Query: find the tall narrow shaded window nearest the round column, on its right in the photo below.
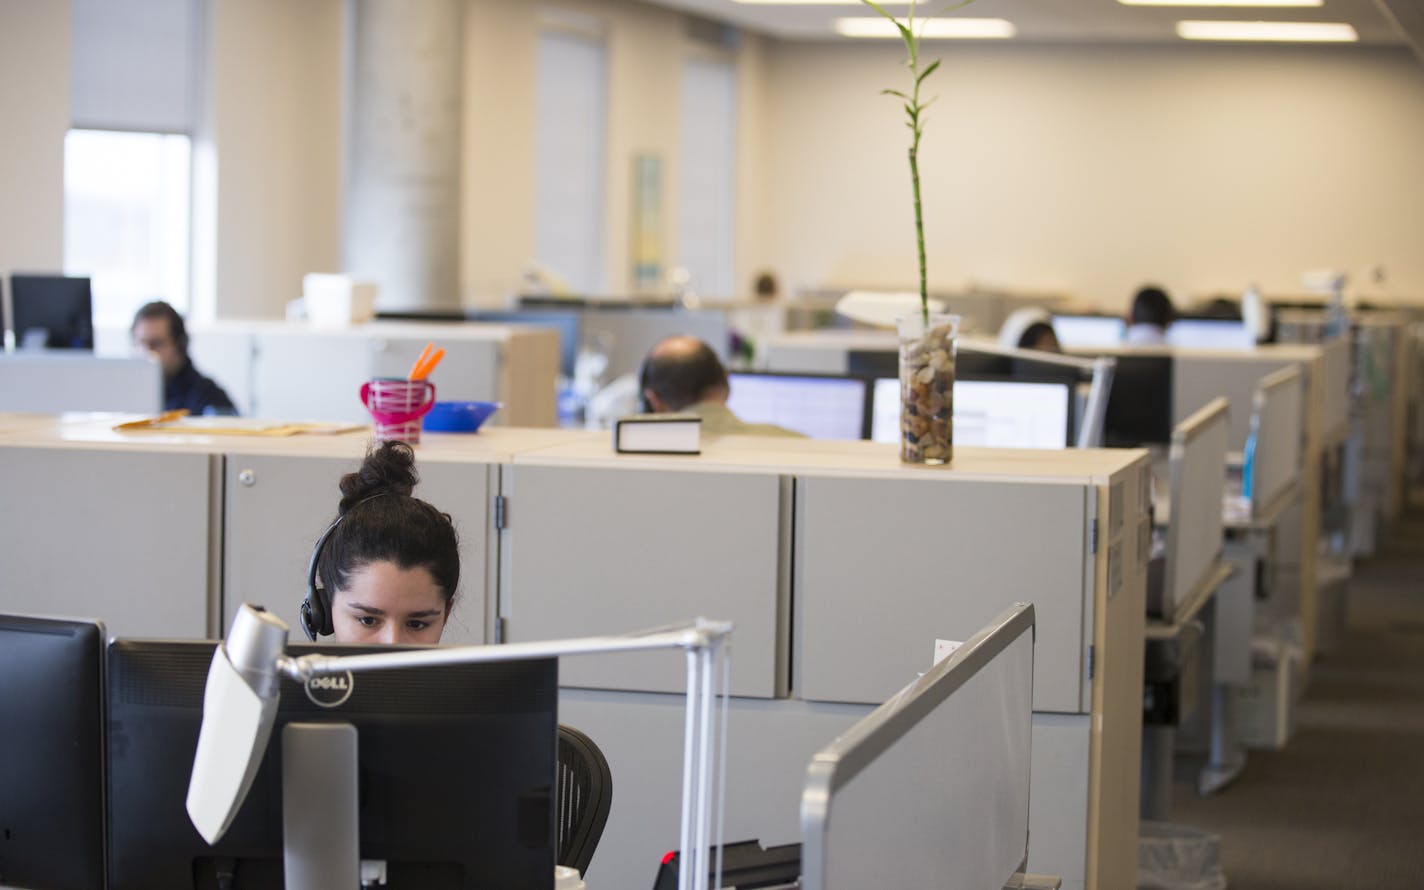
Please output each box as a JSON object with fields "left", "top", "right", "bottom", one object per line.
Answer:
{"left": 534, "top": 28, "right": 607, "bottom": 293}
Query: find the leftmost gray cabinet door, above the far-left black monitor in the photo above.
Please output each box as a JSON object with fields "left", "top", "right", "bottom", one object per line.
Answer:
{"left": 0, "top": 447, "right": 222, "bottom": 639}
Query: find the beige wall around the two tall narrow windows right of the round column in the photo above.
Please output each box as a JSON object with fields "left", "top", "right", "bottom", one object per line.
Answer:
{"left": 460, "top": 0, "right": 762, "bottom": 305}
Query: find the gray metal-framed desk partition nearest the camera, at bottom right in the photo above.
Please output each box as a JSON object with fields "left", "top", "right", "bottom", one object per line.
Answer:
{"left": 802, "top": 604, "right": 1034, "bottom": 890}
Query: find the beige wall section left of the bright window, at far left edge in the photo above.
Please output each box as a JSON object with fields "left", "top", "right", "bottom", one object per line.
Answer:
{"left": 0, "top": 0, "right": 70, "bottom": 280}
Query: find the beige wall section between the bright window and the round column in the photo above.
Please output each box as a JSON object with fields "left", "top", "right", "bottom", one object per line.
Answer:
{"left": 211, "top": 0, "right": 343, "bottom": 318}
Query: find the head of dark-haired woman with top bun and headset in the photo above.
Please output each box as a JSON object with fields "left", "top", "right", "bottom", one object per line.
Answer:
{"left": 300, "top": 441, "right": 460, "bottom": 645}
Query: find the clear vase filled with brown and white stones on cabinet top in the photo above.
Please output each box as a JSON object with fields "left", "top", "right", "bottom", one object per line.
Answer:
{"left": 896, "top": 312, "right": 960, "bottom": 464}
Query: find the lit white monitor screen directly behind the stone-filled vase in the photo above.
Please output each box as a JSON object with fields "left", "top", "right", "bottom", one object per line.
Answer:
{"left": 870, "top": 377, "right": 1074, "bottom": 449}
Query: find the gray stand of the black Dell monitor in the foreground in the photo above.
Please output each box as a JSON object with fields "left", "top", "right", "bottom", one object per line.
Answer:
{"left": 282, "top": 723, "right": 362, "bottom": 890}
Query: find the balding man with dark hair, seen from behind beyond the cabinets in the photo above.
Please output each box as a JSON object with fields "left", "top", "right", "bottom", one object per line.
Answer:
{"left": 638, "top": 335, "right": 802, "bottom": 437}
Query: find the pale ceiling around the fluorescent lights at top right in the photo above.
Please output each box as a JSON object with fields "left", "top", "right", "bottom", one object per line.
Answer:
{"left": 652, "top": 0, "right": 1407, "bottom": 46}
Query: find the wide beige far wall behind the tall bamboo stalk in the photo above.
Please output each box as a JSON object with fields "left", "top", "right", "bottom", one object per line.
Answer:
{"left": 763, "top": 44, "right": 1424, "bottom": 306}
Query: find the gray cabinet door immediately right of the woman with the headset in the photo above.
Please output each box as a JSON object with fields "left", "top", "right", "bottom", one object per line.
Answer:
{"left": 500, "top": 463, "right": 790, "bottom": 698}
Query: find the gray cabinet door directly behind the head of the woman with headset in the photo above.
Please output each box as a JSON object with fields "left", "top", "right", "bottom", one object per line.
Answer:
{"left": 221, "top": 453, "right": 494, "bottom": 645}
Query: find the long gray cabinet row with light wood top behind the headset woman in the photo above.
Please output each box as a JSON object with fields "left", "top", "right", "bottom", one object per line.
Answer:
{"left": 0, "top": 417, "right": 1151, "bottom": 890}
